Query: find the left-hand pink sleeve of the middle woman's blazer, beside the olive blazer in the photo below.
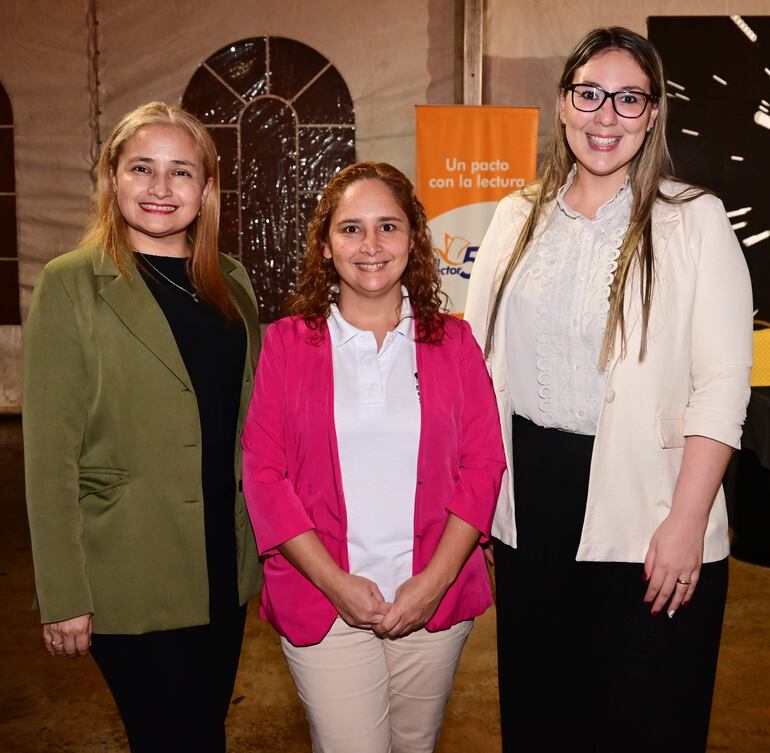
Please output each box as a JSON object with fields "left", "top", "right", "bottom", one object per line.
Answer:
{"left": 242, "top": 325, "right": 314, "bottom": 555}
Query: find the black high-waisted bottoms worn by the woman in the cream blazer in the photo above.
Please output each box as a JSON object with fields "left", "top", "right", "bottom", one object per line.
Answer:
{"left": 494, "top": 416, "right": 727, "bottom": 753}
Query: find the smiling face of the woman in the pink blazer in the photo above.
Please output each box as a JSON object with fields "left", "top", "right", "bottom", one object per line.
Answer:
{"left": 323, "top": 179, "right": 411, "bottom": 310}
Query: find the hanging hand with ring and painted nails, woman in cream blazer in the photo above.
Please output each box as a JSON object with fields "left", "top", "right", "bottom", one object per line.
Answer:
{"left": 644, "top": 510, "right": 706, "bottom": 617}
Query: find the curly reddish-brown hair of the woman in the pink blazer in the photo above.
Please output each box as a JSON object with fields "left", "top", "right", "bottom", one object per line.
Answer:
{"left": 286, "top": 162, "right": 446, "bottom": 344}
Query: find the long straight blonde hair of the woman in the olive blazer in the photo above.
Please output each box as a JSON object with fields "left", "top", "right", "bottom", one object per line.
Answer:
{"left": 81, "top": 102, "right": 237, "bottom": 319}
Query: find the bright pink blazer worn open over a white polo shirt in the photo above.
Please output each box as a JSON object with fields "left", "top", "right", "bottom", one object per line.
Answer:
{"left": 243, "top": 317, "right": 505, "bottom": 646}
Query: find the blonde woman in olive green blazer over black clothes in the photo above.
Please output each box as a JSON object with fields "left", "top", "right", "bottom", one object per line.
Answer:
{"left": 23, "top": 103, "right": 260, "bottom": 753}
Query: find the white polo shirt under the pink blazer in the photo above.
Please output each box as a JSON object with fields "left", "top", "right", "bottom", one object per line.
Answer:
{"left": 327, "top": 288, "right": 420, "bottom": 601}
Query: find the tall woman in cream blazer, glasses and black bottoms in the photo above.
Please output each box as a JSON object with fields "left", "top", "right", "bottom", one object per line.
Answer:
{"left": 465, "top": 28, "right": 752, "bottom": 753}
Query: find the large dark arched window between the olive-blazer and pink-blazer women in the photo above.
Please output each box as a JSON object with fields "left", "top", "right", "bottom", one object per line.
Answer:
{"left": 182, "top": 37, "right": 355, "bottom": 322}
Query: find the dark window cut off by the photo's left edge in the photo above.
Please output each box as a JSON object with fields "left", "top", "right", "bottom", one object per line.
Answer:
{"left": 0, "top": 84, "right": 21, "bottom": 324}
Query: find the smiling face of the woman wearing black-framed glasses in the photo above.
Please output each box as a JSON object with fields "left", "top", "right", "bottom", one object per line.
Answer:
{"left": 559, "top": 49, "right": 657, "bottom": 189}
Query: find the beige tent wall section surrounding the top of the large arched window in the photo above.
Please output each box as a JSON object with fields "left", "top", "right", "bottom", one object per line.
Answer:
{"left": 99, "top": 0, "right": 438, "bottom": 188}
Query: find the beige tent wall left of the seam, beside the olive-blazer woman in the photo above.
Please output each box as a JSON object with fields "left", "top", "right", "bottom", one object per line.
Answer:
{"left": 0, "top": 0, "right": 91, "bottom": 411}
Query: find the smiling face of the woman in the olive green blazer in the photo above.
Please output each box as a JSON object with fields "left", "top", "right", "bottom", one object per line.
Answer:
{"left": 113, "top": 124, "right": 212, "bottom": 256}
